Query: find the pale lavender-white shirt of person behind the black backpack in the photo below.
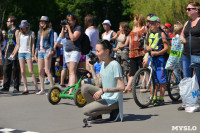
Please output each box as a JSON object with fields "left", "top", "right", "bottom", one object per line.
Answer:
{"left": 85, "top": 29, "right": 99, "bottom": 51}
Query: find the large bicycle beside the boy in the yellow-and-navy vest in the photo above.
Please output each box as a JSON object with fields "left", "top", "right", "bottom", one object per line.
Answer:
{"left": 132, "top": 37, "right": 183, "bottom": 108}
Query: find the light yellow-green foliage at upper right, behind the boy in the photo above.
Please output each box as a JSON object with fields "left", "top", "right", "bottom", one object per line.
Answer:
{"left": 128, "top": 0, "right": 200, "bottom": 24}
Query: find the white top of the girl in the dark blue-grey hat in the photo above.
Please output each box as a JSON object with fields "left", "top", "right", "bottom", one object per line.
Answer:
{"left": 19, "top": 34, "right": 31, "bottom": 53}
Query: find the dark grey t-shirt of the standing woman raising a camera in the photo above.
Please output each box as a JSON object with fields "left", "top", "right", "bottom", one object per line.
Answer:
{"left": 65, "top": 25, "right": 83, "bottom": 52}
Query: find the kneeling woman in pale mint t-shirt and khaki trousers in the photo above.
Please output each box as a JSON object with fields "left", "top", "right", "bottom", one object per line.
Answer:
{"left": 81, "top": 40, "right": 124, "bottom": 121}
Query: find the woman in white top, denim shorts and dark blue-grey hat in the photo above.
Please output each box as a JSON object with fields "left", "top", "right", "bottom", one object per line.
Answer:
{"left": 10, "top": 20, "right": 38, "bottom": 94}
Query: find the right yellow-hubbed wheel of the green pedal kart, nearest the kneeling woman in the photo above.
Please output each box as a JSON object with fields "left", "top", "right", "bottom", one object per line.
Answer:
{"left": 74, "top": 88, "right": 87, "bottom": 107}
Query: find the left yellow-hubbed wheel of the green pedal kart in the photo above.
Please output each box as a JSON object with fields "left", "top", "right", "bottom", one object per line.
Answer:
{"left": 47, "top": 86, "right": 61, "bottom": 105}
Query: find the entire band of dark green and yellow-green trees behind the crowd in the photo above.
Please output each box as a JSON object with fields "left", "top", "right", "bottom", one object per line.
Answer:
{"left": 0, "top": 0, "right": 200, "bottom": 32}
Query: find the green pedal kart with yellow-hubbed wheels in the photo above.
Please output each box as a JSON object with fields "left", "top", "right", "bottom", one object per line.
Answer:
{"left": 47, "top": 68, "right": 91, "bottom": 107}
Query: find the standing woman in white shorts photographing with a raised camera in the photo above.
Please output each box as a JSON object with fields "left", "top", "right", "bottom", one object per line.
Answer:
{"left": 61, "top": 14, "right": 83, "bottom": 94}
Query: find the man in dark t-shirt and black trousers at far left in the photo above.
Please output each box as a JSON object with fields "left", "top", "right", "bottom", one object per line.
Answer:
{"left": 0, "top": 16, "right": 20, "bottom": 93}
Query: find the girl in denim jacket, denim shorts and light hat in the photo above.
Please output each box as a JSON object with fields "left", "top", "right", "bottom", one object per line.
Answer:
{"left": 35, "top": 16, "right": 54, "bottom": 95}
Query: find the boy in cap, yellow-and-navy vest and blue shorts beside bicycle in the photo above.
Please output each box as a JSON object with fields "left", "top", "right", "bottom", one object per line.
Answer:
{"left": 146, "top": 16, "right": 168, "bottom": 106}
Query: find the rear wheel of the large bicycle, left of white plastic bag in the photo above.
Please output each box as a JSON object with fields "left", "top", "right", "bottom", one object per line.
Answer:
{"left": 167, "top": 70, "right": 183, "bottom": 101}
